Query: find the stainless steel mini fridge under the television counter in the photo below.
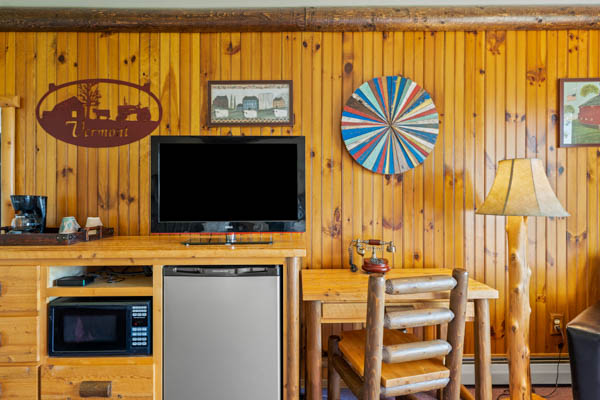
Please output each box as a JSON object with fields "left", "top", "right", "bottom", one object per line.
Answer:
{"left": 163, "top": 266, "right": 282, "bottom": 400}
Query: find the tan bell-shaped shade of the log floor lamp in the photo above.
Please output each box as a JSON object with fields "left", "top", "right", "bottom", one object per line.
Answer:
{"left": 476, "top": 158, "right": 569, "bottom": 217}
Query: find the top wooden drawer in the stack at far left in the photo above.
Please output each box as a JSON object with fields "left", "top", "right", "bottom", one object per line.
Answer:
{"left": 0, "top": 267, "right": 40, "bottom": 316}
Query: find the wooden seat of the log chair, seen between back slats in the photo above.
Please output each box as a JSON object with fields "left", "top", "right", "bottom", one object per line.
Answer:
{"left": 339, "top": 329, "right": 450, "bottom": 388}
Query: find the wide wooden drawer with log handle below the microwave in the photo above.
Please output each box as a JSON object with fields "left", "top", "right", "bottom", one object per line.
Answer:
{"left": 41, "top": 365, "right": 153, "bottom": 400}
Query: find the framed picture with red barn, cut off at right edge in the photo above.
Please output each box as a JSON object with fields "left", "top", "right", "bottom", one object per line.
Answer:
{"left": 559, "top": 78, "right": 600, "bottom": 147}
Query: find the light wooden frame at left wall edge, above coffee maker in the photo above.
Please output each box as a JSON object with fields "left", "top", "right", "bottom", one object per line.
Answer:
{"left": 0, "top": 96, "right": 20, "bottom": 226}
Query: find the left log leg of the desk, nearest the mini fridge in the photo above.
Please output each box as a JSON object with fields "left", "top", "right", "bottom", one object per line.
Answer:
{"left": 306, "top": 301, "right": 323, "bottom": 400}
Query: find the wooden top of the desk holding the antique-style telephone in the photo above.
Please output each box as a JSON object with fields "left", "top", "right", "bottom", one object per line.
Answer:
{"left": 301, "top": 268, "right": 498, "bottom": 303}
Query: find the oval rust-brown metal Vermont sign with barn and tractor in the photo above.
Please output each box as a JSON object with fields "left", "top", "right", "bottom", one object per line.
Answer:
{"left": 35, "top": 79, "right": 162, "bottom": 147}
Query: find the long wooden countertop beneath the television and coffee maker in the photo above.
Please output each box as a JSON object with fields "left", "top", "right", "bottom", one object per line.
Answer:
{"left": 0, "top": 235, "right": 306, "bottom": 265}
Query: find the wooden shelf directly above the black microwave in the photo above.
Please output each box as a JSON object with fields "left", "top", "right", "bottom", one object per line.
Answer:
{"left": 46, "top": 276, "right": 152, "bottom": 297}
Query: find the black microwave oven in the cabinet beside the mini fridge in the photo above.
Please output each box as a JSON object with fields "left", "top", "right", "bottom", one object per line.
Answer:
{"left": 48, "top": 297, "right": 152, "bottom": 357}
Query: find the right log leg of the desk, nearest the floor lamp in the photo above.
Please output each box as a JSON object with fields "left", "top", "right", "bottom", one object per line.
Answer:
{"left": 475, "top": 299, "right": 492, "bottom": 400}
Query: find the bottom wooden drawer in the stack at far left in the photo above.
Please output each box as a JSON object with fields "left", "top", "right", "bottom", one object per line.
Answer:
{"left": 0, "top": 367, "right": 37, "bottom": 400}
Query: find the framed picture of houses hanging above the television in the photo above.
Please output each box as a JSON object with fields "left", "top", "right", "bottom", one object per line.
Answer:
{"left": 207, "top": 81, "right": 294, "bottom": 126}
